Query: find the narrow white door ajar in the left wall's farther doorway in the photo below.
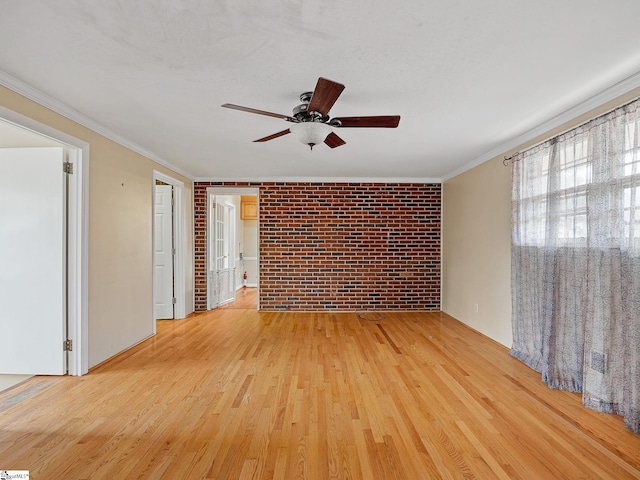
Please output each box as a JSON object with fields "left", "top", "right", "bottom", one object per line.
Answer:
{"left": 153, "top": 185, "right": 174, "bottom": 319}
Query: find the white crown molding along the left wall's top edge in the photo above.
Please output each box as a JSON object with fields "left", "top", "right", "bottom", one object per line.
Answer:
{"left": 0, "top": 70, "right": 193, "bottom": 180}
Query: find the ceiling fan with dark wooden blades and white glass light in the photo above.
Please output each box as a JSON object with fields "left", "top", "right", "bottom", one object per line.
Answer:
{"left": 222, "top": 77, "right": 400, "bottom": 150}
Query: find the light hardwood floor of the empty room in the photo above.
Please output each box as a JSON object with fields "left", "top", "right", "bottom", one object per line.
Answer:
{"left": 0, "top": 309, "right": 640, "bottom": 480}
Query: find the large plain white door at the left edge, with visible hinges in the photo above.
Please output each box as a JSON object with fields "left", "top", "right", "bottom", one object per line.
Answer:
{"left": 0, "top": 148, "right": 67, "bottom": 375}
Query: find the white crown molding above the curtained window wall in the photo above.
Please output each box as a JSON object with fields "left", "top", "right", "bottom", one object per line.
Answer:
{"left": 442, "top": 72, "right": 640, "bottom": 182}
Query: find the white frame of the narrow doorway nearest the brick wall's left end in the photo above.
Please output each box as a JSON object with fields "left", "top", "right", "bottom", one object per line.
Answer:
{"left": 151, "top": 170, "right": 186, "bottom": 335}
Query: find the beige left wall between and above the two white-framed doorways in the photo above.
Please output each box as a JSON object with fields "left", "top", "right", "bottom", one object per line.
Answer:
{"left": 0, "top": 87, "right": 193, "bottom": 367}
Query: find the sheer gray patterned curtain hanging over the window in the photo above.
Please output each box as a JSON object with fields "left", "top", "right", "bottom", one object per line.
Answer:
{"left": 511, "top": 101, "right": 640, "bottom": 433}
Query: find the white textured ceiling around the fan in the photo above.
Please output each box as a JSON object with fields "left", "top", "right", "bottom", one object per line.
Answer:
{"left": 0, "top": 0, "right": 640, "bottom": 181}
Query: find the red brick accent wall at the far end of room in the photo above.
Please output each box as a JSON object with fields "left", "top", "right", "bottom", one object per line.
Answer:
{"left": 194, "top": 182, "right": 441, "bottom": 310}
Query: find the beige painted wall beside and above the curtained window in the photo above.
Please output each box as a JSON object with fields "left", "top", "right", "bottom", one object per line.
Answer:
{"left": 442, "top": 89, "right": 640, "bottom": 347}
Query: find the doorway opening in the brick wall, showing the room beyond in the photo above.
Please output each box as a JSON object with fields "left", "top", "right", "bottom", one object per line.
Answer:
{"left": 207, "top": 187, "right": 259, "bottom": 310}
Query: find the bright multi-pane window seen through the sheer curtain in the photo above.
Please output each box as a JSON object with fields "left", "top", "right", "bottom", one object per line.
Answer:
{"left": 513, "top": 116, "right": 640, "bottom": 250}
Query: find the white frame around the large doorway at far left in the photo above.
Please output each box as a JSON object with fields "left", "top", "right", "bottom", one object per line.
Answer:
{"left": 0, "top": 106, "right": 89, "bottom": 376}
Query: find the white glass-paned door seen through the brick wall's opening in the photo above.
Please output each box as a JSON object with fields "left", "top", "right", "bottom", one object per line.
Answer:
{"left": 209, "top": 199, "right": 236, "bottom": 308}
